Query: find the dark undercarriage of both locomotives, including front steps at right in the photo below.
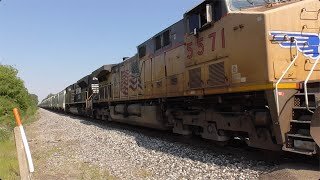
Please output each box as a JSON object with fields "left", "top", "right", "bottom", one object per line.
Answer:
{"left": 66, "top": 86, "right": 320, "bottom": 155}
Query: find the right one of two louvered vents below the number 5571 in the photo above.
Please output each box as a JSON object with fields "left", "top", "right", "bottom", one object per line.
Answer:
{"left": 208, "top": 62, "right": 226, "bottom": 87}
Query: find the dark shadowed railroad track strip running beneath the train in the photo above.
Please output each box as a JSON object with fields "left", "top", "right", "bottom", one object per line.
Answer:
{"left": 51, "top": 111, "right": 320, "bottom": 167}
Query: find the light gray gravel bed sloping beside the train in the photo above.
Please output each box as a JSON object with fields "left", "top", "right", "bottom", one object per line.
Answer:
{"left": 27, "top": 110, "right": 274, "bottom": 179}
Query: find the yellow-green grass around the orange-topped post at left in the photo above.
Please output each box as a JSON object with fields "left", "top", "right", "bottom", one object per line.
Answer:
{"left": 0, "top": 108, "right": 37, "bottom": 180}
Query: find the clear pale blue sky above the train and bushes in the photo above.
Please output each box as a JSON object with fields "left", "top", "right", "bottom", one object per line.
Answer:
{"left": 0, "top": 0, "right": 201, "bottom": 100}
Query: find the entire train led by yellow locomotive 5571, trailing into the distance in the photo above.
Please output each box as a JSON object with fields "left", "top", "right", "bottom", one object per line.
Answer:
{"left": 40, "top": 0, "right": 320, "bottom": 156}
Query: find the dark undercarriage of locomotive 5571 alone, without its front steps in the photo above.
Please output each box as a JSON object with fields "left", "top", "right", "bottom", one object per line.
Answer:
{"left": 93, "top": 91, "right": 281, "bottom": 150}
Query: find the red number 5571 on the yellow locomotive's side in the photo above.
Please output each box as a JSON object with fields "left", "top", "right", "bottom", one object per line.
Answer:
{"left": 185, "top": 28, "right": 226, "bottom": 59}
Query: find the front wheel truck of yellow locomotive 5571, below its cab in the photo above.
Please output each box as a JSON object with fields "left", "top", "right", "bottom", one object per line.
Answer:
{"left": 166, "top": 92, "right": 281, "bottom": 150}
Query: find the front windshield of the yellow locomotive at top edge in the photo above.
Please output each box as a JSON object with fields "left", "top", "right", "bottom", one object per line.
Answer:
{"left": 229, "top": 0, "right": 268, "bottom": 10}
